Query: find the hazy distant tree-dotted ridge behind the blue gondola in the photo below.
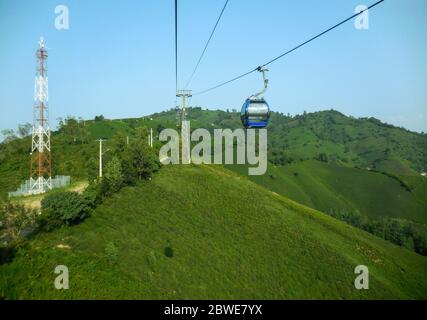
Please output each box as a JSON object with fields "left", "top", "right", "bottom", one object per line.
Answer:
{"left": 145, "top": 108, "right": 427, "bottom": 175}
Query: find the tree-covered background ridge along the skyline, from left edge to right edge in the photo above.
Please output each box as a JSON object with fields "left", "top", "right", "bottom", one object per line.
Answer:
{"left": 0, "top": 107, "right": 427, "bottom": 198}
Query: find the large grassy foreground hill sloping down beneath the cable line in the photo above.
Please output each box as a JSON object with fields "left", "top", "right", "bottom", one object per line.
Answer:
{"left": 0, "top": 166, "right": 427, "bottom": 299}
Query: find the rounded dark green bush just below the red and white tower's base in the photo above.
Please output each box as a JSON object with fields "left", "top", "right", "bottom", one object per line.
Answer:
{"left": 39, "top": 191, "right": 94, "bottom": 231}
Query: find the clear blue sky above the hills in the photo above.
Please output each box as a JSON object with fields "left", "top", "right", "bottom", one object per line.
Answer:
{"left": 0, "top": 0, "right": 427, "bottom": 131}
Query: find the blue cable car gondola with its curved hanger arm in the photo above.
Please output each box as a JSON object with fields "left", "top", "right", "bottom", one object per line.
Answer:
{"left": 240, "top": 67, "right": 270, "bottom": 128}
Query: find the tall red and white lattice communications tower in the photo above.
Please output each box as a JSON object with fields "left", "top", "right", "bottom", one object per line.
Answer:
{"left": 29, "top": 38, "right": 52, "bottom": 194}
